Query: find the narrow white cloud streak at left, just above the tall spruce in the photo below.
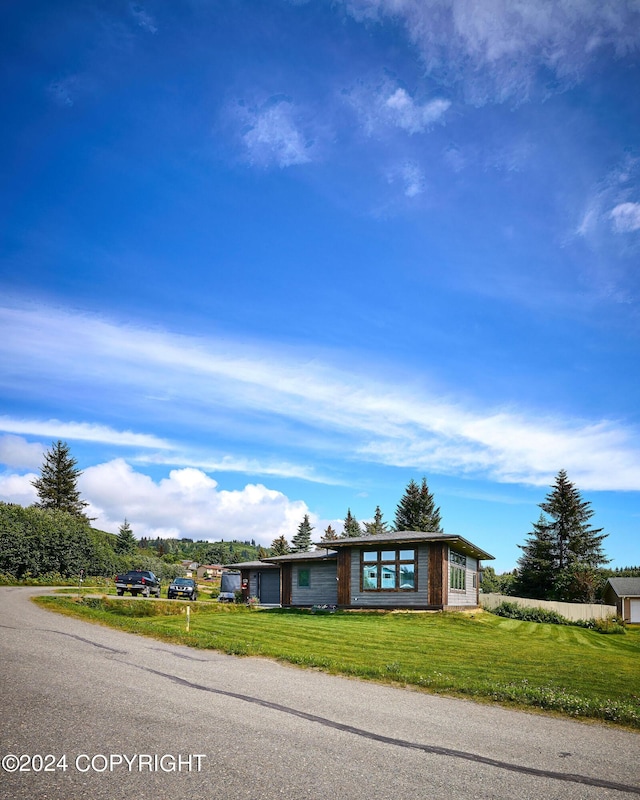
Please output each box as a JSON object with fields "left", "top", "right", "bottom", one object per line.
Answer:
{"left": 0, "top": 416, "right": 170, "bottom": 450}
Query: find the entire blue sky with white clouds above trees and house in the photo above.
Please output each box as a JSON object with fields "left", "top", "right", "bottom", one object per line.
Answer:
{"left": 0, "top": 0, "right": 640, "bottom": 571}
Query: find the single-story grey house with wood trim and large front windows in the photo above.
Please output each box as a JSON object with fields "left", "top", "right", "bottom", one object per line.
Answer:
{"left": 230, "top": 531, "right": 493, "bottom": 611}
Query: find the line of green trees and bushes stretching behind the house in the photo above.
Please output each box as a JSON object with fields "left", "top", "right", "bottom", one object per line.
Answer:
{"left": 5, "top": 441, "right": 624, "bottom": 602}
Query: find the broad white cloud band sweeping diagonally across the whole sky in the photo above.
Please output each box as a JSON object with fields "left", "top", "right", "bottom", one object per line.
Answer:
{"left": 0, "top": 308, "right": 640, "bottom": 490}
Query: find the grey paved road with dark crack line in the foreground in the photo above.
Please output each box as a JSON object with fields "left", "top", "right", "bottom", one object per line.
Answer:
{"left": 0, "top": 587, "right": 640, "bottom": 800}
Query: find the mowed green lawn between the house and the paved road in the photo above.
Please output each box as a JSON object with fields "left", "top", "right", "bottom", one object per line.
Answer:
{"left": 36, "top": 597, "right": 640, "bottom": 729}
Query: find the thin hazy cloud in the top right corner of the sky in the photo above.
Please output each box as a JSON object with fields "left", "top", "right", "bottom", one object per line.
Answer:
{"left": 344, "top": 0, "right": 640, "bottom": 105}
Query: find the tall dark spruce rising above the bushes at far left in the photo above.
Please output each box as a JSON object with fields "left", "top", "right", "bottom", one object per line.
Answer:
{"left": 32, "top": 439, "right": 89, "bottom": 522}
